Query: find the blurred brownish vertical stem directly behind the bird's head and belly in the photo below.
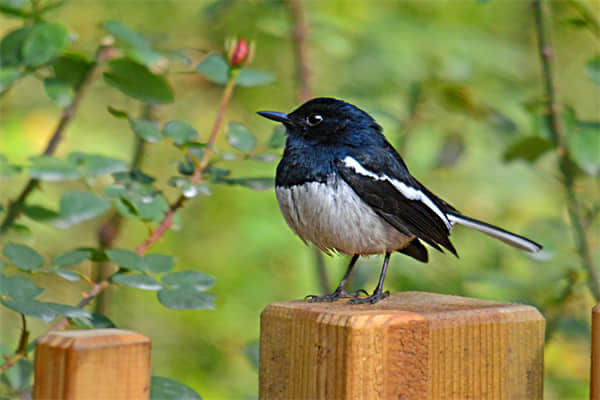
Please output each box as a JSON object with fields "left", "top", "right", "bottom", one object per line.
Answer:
{"left": 288, "top": 0, "right": 331, "bottom": 295}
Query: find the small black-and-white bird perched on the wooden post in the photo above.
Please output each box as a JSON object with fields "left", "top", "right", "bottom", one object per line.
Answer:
{"left": 257, "top": 97, "right": 542, "bottom": 304}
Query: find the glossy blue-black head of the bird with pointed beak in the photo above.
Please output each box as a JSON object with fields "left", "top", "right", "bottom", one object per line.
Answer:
{"left": 258, "top": 97, "right": 381, "bottom": 146}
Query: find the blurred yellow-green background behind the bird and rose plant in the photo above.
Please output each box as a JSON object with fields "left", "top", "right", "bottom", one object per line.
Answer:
{"left": 0, "top": 0, "right": 600, "bottom": 399}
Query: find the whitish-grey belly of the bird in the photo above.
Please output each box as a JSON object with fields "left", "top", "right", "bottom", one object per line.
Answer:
{"left": 275, "top": 178, "right": 412, "bottom": 255}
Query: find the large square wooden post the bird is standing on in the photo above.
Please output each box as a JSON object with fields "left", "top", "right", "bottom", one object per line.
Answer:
{"left": 259, "top": 292, "right": 545, "bottom": 400}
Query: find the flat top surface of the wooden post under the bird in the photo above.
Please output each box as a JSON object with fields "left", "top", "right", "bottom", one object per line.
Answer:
{"left": 263, "top": 292, "right": 544, "bottom": 324}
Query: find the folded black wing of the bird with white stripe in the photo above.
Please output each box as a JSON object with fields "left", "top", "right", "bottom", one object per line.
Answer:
{"left": 336, "top": 144, "right": 456, "bottom": 255}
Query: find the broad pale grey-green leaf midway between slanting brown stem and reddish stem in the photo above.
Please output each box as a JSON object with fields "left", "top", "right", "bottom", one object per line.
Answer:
{"left": 54, "top": 190, "right": 110, "bottom": 229}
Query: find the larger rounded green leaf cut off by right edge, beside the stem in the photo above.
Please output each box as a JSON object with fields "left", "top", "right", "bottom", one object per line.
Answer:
{"left": 567, "top": 120, "right": 600, "bottom": 175}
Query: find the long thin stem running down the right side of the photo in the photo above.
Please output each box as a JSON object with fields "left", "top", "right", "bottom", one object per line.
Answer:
{"left": 533, "top": 0, "right": 600, "bottom": 301}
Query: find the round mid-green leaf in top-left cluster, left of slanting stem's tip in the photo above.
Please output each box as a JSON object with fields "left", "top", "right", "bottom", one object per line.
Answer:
{"left": 22, "top": 22, "right": 69, "bottom": 66}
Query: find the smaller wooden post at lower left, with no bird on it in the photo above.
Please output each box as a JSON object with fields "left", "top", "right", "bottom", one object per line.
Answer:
{"left": 33, "top": 329, "right": 151, "bottom": 400}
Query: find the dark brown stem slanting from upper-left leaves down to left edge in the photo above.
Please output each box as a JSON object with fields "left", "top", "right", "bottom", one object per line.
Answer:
{"left": 0, "top": 44, "right": 114, "bottom": 235}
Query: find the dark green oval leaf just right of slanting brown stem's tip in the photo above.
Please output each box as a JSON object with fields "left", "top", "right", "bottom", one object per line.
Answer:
{"left": 104, "top": 58, "right": 174, "bottom": 104}
